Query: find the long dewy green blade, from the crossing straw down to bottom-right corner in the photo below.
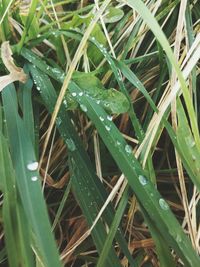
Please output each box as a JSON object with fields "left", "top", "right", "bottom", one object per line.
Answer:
{"left": 69, "top": 84, "right": 200, "bottom": 267}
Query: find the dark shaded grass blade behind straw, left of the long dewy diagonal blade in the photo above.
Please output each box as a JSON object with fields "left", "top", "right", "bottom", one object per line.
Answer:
{"left": 29, "top": 66, "right": 124, "bottom": 266}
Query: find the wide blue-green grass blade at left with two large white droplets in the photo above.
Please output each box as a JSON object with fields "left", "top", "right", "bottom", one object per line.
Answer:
{"left": 2, "top": 85, "right": 61, "bottom": 267}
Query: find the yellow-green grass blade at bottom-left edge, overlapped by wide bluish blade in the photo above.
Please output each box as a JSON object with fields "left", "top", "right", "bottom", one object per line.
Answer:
{"left": 0, "top": 133, "right": 34, "bottom": 267}
